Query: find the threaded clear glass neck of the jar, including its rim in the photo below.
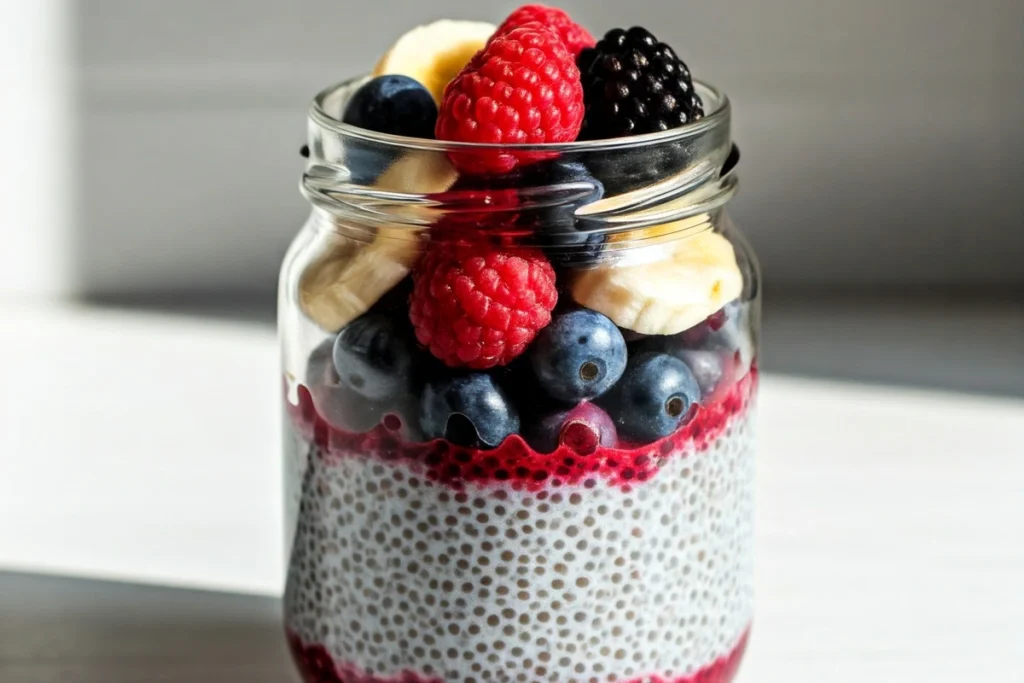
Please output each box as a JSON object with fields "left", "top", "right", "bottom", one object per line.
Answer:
{"left": 302, "top": 79, "right": 736, "bottom": 241}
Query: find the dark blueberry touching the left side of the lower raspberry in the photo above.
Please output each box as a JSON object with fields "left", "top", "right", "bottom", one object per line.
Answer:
{"left": 334, "top": 312, "right": 414, "bottom": 400}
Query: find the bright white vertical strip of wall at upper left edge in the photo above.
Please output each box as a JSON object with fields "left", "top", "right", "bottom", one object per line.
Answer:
{"left": 0, "top": 0, "right": 76, "bottom": 298}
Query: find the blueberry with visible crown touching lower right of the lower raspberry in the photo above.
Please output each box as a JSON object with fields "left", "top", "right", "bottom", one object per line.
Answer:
{"left": 529, "top": 308, "right": 626, "bottom": 402}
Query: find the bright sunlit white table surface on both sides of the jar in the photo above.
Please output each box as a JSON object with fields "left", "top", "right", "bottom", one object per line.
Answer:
{"left": 0, "top": 306, "right": 1024, "bottom": 683}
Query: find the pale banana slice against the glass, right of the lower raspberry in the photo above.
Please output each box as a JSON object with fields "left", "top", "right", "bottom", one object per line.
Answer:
{"left": 572, "top": 228, "right": 743, "bottom": 335}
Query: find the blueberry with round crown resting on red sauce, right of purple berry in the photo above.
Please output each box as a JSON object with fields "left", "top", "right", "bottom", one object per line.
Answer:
{"left": 601, "top": 351, "right": 700, "bottom": 442}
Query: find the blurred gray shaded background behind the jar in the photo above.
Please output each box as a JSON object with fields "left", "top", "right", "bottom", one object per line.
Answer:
{"left": 72, "top": 0, "right": 1024, "bottom": 394}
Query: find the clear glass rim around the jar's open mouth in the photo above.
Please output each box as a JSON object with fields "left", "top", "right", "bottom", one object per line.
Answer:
{"left": 309, "top": 75, "right": 731, "bottom": 154}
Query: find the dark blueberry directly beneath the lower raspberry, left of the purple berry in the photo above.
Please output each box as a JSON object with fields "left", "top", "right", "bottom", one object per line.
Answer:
{"left": 420, "top": 373, "right": 519, "bottom": 447}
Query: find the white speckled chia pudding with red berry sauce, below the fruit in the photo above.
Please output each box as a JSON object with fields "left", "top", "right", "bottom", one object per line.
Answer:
{"left": 285, "top": 369, "right": 757, "bottom": 683}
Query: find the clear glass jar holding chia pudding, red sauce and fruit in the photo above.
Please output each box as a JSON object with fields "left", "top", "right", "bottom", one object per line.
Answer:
{"left": 280, "top": 74, "right": 760, "bottom": 683}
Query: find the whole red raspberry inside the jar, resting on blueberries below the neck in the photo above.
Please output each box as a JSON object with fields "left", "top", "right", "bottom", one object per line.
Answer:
{"left": 409, "top": 242, "right": 558, "bottom": 370}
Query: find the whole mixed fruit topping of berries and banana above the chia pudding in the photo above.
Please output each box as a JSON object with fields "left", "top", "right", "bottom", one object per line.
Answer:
{"left": 297, "top": 4, "right": 756, "bottom": 454}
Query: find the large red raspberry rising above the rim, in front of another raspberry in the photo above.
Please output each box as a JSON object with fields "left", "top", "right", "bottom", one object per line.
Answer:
{"left": 434, "top": 24, "right": 584, "bottom": 175}
